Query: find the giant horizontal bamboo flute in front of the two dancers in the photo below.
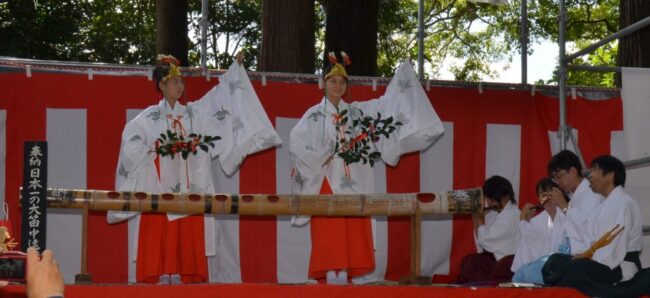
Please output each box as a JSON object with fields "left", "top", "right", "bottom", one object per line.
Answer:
{"left": 19, "top": 188, "right": 482, "bottom": 216}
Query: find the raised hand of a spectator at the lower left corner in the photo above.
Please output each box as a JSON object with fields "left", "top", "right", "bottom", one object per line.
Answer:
{"left": 27, "top": 247, "right": 64, "bottom": 298}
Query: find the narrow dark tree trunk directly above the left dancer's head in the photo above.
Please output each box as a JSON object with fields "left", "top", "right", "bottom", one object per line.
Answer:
{"left": 156, "top": 0, "right": 188, "bottom": 66}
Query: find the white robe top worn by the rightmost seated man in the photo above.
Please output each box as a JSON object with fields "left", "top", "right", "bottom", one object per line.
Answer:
{"left": 587, "top": 186, "right": 643, "bottom": 281}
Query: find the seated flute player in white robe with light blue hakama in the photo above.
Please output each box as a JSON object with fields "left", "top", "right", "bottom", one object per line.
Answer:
{"left": 510, "top": 178, "right": 570, "bottom": 284}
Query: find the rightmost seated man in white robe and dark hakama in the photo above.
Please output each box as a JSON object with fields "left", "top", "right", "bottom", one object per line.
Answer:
{"left": 542, "top": 155, "right": 650, "bottom": 297}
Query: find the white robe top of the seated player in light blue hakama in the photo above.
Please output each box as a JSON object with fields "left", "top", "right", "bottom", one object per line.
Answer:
{"left": 510, "top": 207, "right": 566, "bottom": 272}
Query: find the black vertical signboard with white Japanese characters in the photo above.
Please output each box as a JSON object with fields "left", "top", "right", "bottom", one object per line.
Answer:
{"left": 21, "top": 142, "right": 47, "bottom": 252}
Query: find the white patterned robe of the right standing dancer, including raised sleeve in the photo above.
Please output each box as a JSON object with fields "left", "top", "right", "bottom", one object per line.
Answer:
{"left": 289, "top": 62, "right": 444, "bottom": 217}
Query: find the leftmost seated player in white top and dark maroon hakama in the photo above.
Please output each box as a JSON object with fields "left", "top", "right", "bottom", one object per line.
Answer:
{"left": 458, "top": 176, "right": 520, "bottom": 284}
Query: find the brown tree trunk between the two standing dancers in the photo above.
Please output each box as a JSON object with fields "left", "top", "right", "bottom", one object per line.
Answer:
{"left": 258, "top": 0, "right": 316, "bottom": 73}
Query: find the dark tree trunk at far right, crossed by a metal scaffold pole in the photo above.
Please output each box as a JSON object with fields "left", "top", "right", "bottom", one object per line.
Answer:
{"left": 616, "top": 0, "right": 650, "bottom": 87}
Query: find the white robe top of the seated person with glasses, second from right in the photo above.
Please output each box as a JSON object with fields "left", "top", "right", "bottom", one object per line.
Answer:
{"left": 566, "top": 178, "right": 603, "bottom": 255}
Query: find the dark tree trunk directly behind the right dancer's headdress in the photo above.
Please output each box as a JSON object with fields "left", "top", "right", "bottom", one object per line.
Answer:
{"left": 321, "top": 0, "right": 379, "bottom": 76}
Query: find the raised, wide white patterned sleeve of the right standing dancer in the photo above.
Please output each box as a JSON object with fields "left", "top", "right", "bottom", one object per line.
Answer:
{"left": 356, "top": 61, "right": 444, "bottom": 165}
